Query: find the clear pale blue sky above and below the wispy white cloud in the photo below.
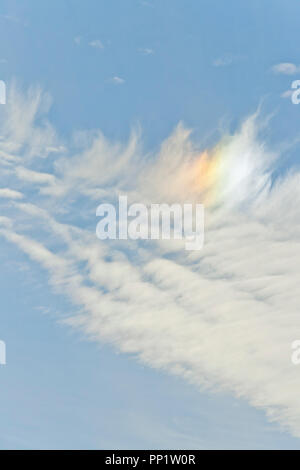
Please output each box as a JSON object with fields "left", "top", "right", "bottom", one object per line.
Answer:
{"left": 0, "top": 0, "right": 300, "bottom": 449}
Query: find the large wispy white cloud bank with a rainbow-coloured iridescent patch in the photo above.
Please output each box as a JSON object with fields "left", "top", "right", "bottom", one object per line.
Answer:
{"left": 0, "top": 85, "right": 300, "bottom": 437}
